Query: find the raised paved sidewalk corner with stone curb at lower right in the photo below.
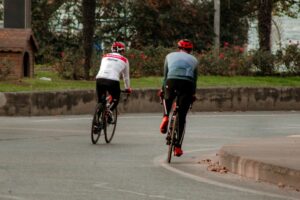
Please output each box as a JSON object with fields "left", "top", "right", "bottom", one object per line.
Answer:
{"left": 218, "top": 135, "right": 300, "bottom": 191}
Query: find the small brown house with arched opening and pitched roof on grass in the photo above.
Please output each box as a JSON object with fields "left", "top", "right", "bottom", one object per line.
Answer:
{"left": 0, "top": 28, "right": 38, "bottom": 79}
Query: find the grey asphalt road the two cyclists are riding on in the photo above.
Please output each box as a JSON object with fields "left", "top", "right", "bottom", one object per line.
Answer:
{"left": 0, "top": 112, "right": 300, "bottom": 200}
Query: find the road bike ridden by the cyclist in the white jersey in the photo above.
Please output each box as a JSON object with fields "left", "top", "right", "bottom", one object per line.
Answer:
{"left": 91, "top": 90, "right": 129, "bottom": 144}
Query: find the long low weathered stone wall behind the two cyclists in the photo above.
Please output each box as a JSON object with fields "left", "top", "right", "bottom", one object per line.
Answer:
{"left": 0, "top": 88, "right": 300, "bottom": 116}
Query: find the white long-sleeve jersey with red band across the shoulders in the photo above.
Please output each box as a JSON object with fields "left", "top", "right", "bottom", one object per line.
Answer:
{"left": 96, "top": 53, "right": 130, "bottom": 89}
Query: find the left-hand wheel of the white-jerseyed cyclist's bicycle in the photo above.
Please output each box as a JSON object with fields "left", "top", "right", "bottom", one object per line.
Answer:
{"left": 91, "top": 103, "right": 103, "bottom": 144}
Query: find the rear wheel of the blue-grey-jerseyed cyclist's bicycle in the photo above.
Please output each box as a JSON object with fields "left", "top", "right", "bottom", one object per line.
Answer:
{"left": 167, "top": 114, "right": 179, "bottom": 163}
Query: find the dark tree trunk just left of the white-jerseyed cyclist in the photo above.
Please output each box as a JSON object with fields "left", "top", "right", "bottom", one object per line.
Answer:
{"left": 82, "top": 0, "right": 96, "bottom": 80}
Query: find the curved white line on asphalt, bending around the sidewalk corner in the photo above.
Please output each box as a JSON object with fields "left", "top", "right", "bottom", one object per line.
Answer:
{"left": 154, "top": 148, "right": 299, "bottom": 200}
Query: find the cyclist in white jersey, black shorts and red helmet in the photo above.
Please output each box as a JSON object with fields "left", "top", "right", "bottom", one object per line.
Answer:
{"left": 96, "top": 42, "right": 132, "bottom": 110}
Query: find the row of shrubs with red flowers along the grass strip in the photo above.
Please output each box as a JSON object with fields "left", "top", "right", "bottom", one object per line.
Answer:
{"left": 49, "top": 44, "right": 300, "bottom": 80}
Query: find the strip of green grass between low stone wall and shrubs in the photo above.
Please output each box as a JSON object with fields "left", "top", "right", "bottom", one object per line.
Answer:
{"left": 0, "top": 70, "right": 300, "bottom": 92}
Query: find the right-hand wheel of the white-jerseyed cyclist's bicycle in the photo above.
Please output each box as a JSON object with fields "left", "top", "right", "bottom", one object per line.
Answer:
{"left": 104, "top": 108, "right": 118, "bottom": 143}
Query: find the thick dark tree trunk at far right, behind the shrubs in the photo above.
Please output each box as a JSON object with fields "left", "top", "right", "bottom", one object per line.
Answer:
{"left": 258, "top": 0, "right": 273, "bottom": 52}
